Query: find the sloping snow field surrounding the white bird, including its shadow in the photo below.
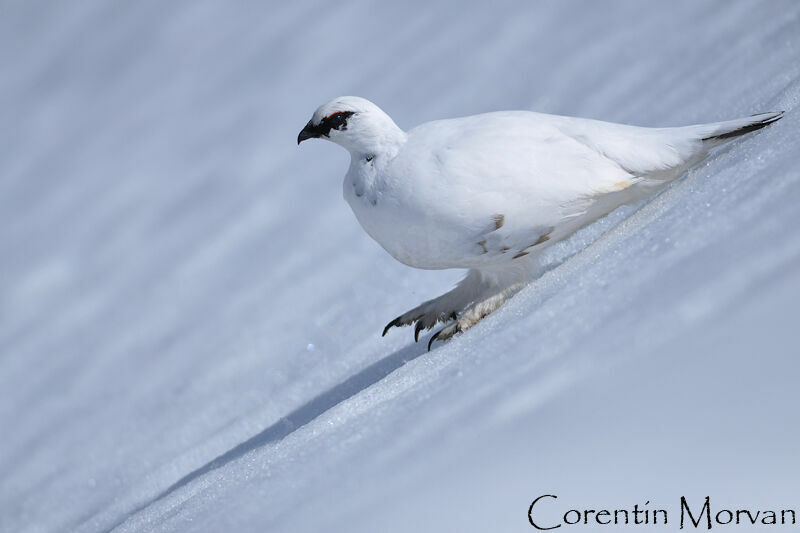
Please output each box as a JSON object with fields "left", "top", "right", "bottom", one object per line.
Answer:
{"left": 0, "top": 0, "right": 800, "bottom": 532}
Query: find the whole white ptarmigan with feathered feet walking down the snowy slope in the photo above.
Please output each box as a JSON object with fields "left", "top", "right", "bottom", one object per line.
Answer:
{"left": 297, "top": 96, "right": 783, "bottom": 349}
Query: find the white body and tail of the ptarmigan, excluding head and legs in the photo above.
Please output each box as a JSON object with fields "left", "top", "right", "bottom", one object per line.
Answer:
{"left": 351, "top": 107, "right": 779, "bottom": 268}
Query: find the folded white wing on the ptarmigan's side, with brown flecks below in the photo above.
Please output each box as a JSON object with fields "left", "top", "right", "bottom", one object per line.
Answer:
{"left": 394, "top": 112, "right": 641, "bottom": 264}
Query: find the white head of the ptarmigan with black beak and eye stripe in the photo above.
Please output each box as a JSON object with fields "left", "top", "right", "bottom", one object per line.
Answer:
{"left": 297, "top": 96, "right": 405, "bottom": 154}
